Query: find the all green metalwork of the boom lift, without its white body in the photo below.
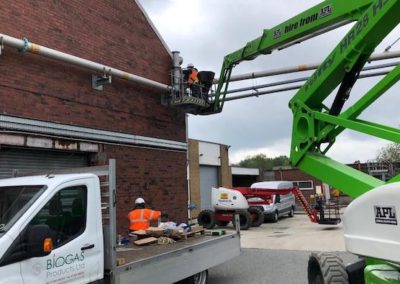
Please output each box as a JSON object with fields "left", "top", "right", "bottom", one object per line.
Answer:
{"left": 209, "top": 0, "right": 400, "bottom": 283}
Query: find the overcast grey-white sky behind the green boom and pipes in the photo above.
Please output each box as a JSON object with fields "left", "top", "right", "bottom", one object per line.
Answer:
{"left": 139, "top": 0, "right": 400, "bottom": 163}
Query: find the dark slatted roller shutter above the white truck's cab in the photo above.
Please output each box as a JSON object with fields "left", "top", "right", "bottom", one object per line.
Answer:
{"left": 0, "top": 148, "right": 89, "bottom": 178}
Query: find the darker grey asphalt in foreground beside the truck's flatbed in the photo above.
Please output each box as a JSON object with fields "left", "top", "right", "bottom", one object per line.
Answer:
{"left": 207, "top": 249, "right": 357, "bottom": 284}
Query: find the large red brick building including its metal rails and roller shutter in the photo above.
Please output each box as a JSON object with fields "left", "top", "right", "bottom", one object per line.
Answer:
{"left": 0, "top": 0, "right": 188, "bottom": 232}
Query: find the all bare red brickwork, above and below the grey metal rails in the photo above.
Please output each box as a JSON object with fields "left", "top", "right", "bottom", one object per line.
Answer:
{"left": 0, "top": 0, "right": 187, "bottom": 232}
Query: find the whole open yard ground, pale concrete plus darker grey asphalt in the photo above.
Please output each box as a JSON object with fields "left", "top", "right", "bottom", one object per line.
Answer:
{"left": 208, "top": 214, "right": 357, "bottom": 284}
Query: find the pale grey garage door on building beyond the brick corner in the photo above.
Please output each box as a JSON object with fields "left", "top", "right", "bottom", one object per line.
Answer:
{"left": 200, "top": 166, "right": 218, "bottom": 210}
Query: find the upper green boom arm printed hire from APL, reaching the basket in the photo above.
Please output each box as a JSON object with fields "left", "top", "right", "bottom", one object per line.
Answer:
{"left": 209, "top": 0, "right": 372, "bottom": 115}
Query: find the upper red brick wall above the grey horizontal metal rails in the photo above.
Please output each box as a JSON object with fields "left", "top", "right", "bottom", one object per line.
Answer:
{"left": 0, "top": 0, "right": 185, "bottom": 141}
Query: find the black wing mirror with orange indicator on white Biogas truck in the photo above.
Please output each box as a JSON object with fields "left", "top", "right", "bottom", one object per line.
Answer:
{"left": 27, "top": 225, "right": 53, "bottom": 257}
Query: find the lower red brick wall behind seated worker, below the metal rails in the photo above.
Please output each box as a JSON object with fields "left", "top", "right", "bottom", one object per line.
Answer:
{"left": 104, "top": 145, "right": 188, "bottom": 232}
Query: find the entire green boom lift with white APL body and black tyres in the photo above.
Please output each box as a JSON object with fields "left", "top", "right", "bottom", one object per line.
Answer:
{"left": 170, "top": 0, "right": 400, "bottom": 283}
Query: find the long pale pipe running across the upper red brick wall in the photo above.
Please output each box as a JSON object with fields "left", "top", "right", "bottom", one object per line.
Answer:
{"left": 0, "top": 33, "right": 170, "bottom": 91}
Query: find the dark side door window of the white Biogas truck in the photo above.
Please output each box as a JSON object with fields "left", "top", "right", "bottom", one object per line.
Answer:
{"left": 29, "top": 186, "right": 87, "bottom": 248}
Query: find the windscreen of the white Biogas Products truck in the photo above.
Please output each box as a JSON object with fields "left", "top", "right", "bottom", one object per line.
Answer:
{"left": 0, "top": 185, "right": 46, "bottom": 234}
